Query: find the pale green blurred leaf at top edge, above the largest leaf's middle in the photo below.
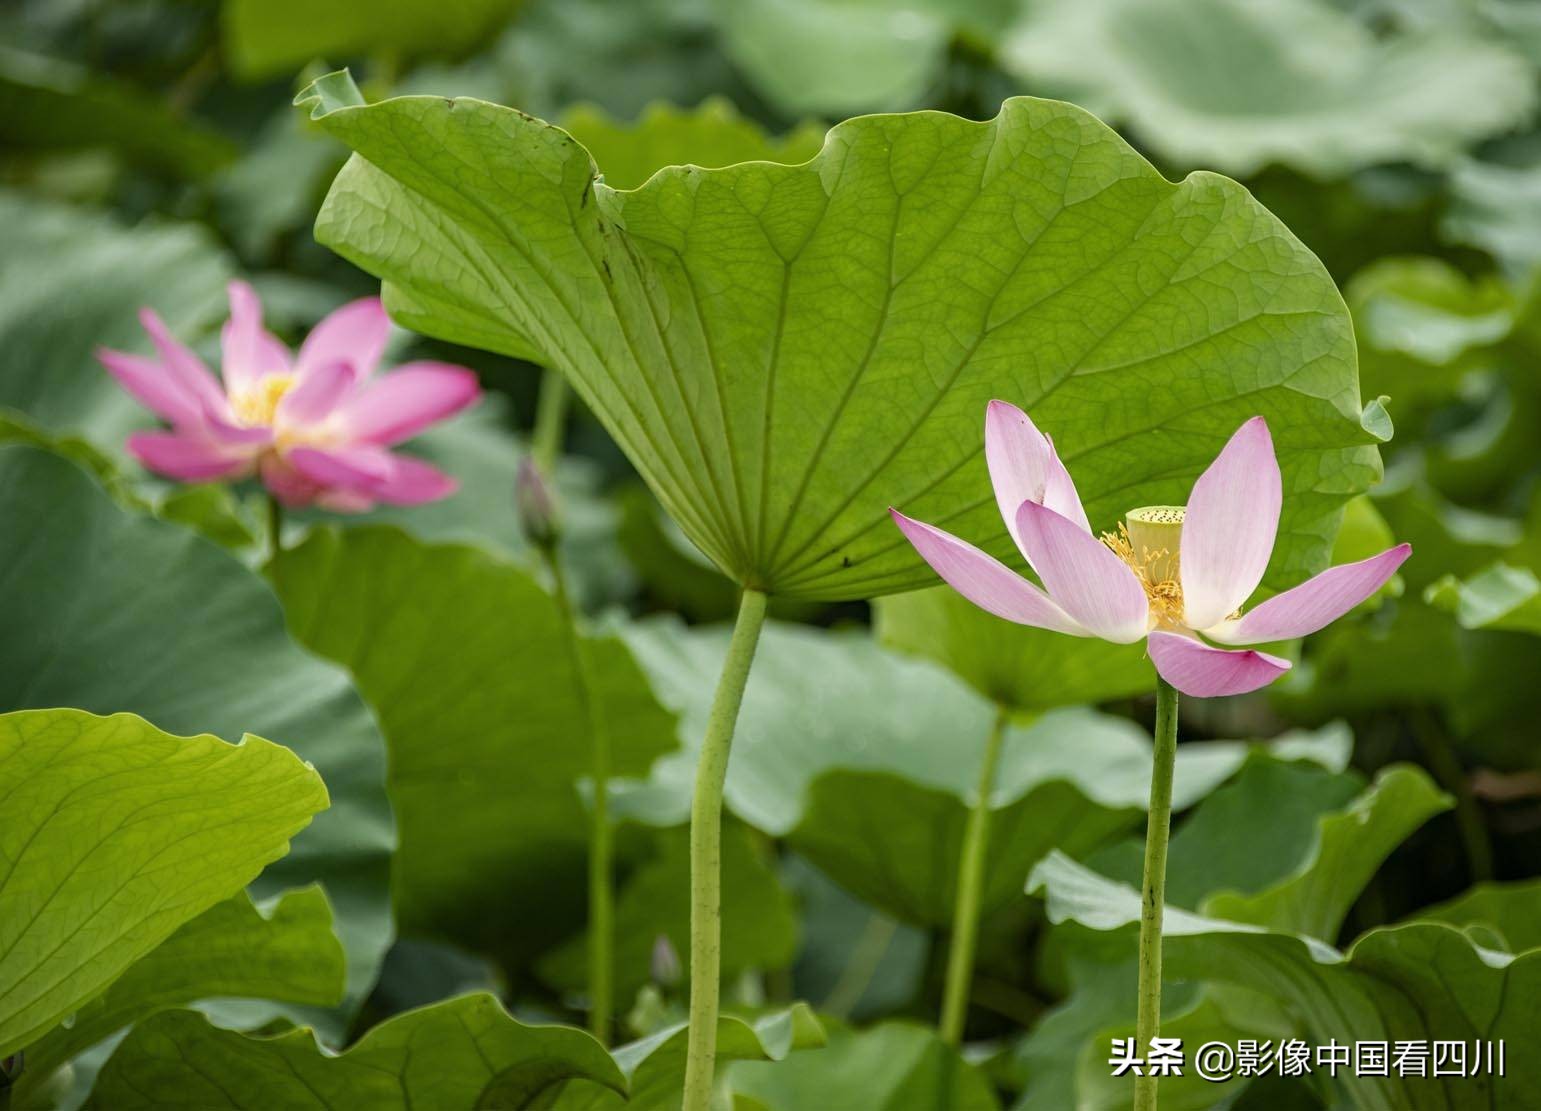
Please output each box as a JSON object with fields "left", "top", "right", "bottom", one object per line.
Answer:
{"left": 713, "top": 0, "right": 1014, "bottom": 117}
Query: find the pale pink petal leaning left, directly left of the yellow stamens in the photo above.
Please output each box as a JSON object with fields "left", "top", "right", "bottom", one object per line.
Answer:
{"left": 1017, "top": 501, "right": 1150, "bottom": 644}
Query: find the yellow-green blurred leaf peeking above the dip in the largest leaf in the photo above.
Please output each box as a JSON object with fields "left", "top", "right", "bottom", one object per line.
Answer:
{"left": 561, "top": 97, "right": 824, "bottom": 190}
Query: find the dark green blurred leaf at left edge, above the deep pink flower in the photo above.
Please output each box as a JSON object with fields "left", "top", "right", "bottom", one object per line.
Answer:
{"left": 0, "top": 46, "right": 236, "bottom": 177}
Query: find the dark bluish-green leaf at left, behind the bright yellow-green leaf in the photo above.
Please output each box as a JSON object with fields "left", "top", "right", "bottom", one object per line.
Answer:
{"left": 0, "top": 445, "right": 396, "bottom": 1034}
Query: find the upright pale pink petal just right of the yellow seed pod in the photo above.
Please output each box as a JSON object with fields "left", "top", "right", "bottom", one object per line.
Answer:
{"left": 1177, "top": 416, "right": 1284, "bottom": 629}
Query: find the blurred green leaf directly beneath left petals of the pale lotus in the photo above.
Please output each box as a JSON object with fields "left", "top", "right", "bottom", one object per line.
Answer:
{"left": 872, "top": 585, "right": 1152, "bottom": 712}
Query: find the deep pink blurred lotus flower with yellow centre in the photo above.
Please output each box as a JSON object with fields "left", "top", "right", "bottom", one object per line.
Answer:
{"left": 97, "top": 282, "right": 481, "bottom": 513}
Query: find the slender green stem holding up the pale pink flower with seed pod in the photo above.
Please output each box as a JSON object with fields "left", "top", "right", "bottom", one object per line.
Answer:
{"left": 1134, "top": 675, "right": 1177, "bottom": 1111}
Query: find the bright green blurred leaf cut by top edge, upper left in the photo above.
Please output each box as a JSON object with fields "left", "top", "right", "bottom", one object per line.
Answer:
{"left": 220, "top": 0, "right": 518, "bottom": 80}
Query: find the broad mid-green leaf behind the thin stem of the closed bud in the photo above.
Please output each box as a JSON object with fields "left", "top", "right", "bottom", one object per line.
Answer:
{"left": 268, "top": 525, "right": 675, "bottom": 955}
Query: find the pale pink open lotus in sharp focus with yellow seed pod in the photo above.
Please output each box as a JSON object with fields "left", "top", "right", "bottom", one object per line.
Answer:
{"left": 889, "top": 401, "right": 1412, "bottom": 698}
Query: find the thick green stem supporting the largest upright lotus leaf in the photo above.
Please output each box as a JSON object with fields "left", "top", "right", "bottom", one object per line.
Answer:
{"left": 683, "top": 587, "right": 766, "bottom": 1111}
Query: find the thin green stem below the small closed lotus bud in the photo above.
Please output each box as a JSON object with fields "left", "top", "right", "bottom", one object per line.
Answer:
{"left": 544, "top": 547, "right": 615, "bottom": 1045}
